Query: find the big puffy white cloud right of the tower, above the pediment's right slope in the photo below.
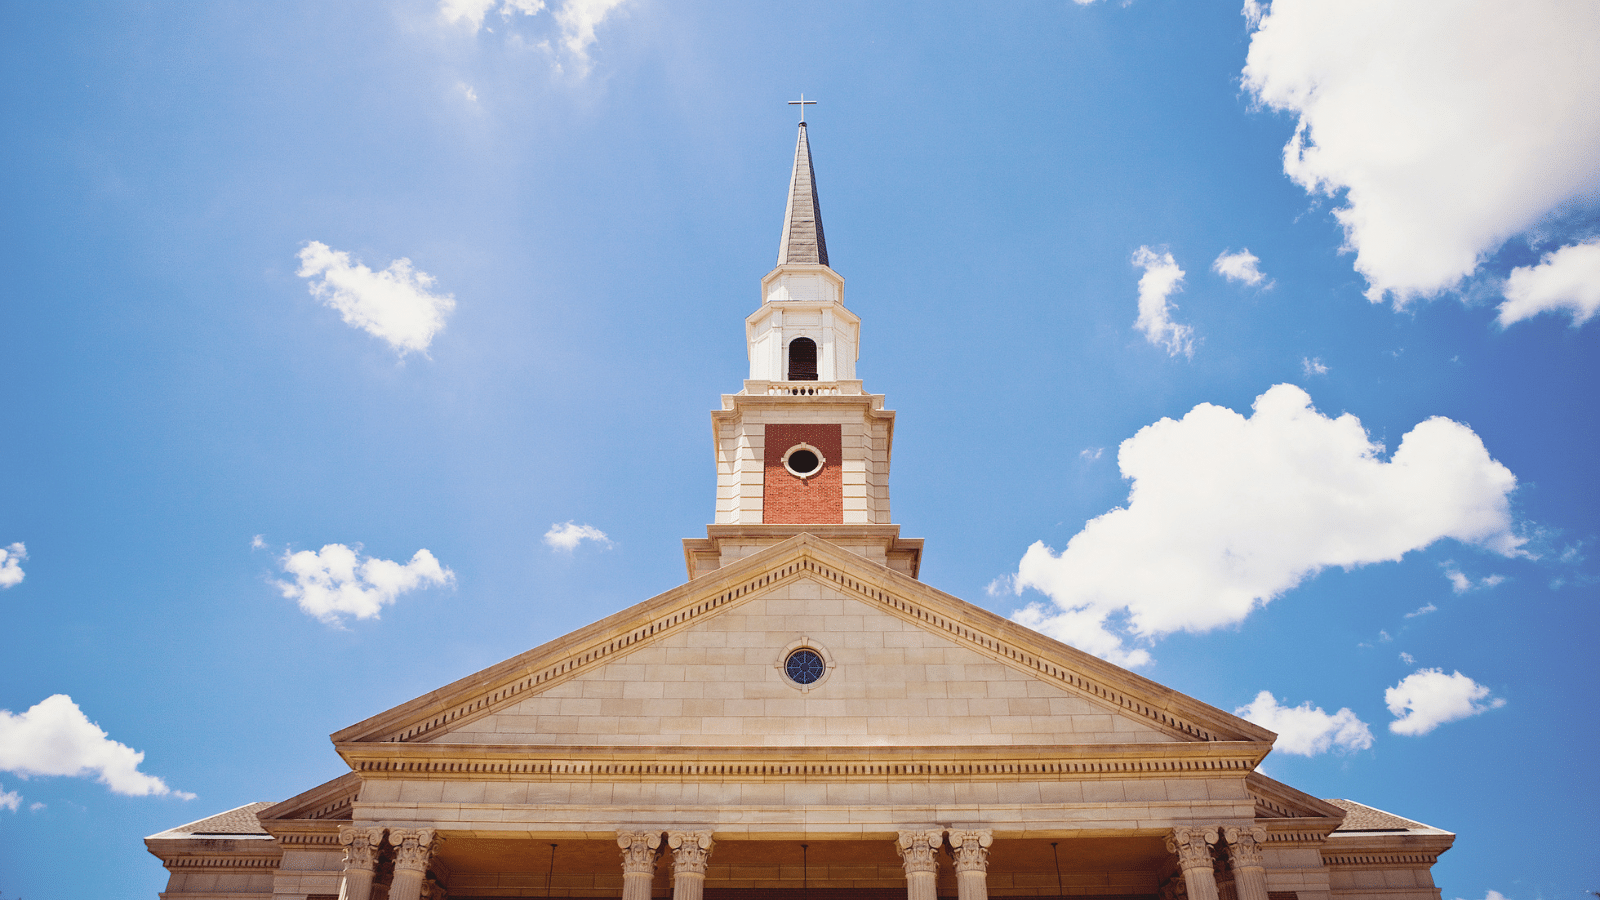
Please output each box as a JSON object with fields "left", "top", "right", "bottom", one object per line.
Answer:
{"left": 1016, "top": 384, "right": 1523, "bottom": 665}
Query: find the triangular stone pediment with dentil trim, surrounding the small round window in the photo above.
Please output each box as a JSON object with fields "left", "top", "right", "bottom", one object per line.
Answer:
{"left": 333, "top": 535, "right": 1272, "bottom": 754}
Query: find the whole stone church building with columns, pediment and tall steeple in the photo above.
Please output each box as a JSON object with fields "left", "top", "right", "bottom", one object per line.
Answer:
{"left": 146, "top": 117, "right": 1454, "bottom": 900}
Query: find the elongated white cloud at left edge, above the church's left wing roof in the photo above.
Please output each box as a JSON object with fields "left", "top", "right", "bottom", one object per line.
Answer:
{"left": 0, "top": 693, "right": 194, "bottom": 794}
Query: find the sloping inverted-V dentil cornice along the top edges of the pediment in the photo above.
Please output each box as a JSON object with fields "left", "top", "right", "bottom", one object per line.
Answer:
{"left": 331, "top": 535, "right": 1274, "bottom": 743}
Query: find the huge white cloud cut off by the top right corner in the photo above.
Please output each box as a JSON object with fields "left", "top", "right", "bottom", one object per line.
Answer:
{"left": 1243, "top": 0, "right": 1600, "bottom": 304}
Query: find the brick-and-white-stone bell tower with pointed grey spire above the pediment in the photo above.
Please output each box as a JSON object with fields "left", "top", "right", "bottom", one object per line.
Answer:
{"left": 683, "top": 119, "right": 922, "bottom": 580}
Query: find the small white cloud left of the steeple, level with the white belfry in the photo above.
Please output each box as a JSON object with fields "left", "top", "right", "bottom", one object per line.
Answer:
{"left": 296, "top": 240, "right": 456, "bottom": 356}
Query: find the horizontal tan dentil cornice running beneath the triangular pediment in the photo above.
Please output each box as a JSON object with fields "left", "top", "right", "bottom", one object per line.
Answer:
{"left": 336, "top": 741, "right": 1270, "bottom": 781}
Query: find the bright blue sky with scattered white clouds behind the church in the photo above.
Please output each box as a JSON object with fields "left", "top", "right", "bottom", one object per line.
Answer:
{"left": 0, "top": 0, "right": 1600, "bottom": 900}
